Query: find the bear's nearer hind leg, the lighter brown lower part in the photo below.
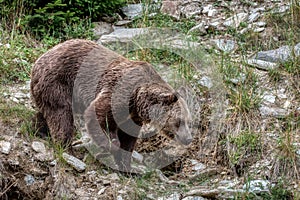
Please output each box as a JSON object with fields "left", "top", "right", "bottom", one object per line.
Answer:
{"left": 45, "top": 107, "right": 75, "bottom": 146}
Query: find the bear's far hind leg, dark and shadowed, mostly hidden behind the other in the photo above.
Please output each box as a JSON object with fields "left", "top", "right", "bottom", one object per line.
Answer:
{"left": 32, "top": 112, "right": 49, "bottom": 139}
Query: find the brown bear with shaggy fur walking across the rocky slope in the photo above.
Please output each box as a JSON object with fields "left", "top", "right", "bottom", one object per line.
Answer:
{"left": 30, "top": 39, "right": 192, "bottom": 170}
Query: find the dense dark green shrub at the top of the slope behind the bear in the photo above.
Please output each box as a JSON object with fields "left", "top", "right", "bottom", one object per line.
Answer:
{"left": 0, "top": 0, "right": 125, "bottom": 39}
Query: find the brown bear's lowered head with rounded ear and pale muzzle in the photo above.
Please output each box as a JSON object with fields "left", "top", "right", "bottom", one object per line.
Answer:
{"left": 136, "top": 83, "right": 193, "bottom": 145}
